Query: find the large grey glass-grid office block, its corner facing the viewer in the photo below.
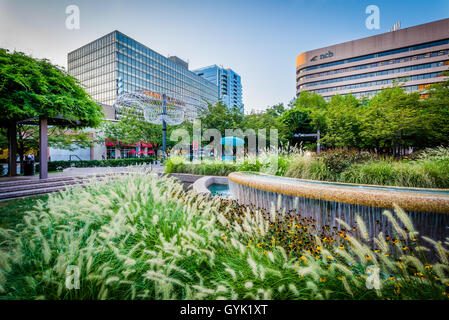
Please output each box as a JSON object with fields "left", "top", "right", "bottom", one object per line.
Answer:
{"left": 67, "top": 31, "right": 218, "bottom": 117}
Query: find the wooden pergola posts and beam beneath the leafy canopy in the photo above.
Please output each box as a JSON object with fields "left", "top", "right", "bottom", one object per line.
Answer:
{"left": 8, "top": 116, "right": 84, "bottom": 179}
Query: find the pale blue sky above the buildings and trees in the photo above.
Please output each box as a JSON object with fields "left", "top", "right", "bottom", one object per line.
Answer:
{"left": 0, "top": 0, "right": 449, "bottom": 112}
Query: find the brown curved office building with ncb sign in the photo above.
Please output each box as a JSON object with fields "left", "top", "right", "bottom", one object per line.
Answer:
{"left": 296, "top": 19, "right": 449, "bottom": 100}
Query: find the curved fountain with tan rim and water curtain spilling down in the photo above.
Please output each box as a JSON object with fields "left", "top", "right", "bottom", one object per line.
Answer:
{"left": 228, "top": 172, "right": 449, "bottom": 240}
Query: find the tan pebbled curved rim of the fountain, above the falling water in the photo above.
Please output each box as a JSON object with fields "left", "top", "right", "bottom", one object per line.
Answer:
{"left": 228, "top": 172, "right": 449, "bottom": 214}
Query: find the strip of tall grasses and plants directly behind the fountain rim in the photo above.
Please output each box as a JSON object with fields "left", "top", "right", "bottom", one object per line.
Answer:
{"left": 166, "top": 147, "right": 449, "bottom": 188}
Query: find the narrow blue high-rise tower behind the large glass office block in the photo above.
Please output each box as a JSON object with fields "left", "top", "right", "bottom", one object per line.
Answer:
{"left": 193, "top": 65, "right": 244, "bottom": 113}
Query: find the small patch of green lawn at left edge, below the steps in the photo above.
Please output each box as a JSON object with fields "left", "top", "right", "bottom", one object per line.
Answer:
{"left": 0, "top": 194, "right": 48, "bottom": 229}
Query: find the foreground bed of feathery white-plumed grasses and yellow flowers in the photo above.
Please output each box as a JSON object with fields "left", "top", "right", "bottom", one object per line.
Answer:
{"left": 0, "top": 174, "right": 449, "bottom": 299}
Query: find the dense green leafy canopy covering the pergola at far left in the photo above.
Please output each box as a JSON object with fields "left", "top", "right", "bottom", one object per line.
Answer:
{"left": 0, "top": 48, "right": 103, "bottom": 174}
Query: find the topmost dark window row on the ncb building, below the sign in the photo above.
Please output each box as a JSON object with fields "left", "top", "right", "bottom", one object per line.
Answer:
{"left": 298, "top": 50, "right": 449, "bottom": 81}
